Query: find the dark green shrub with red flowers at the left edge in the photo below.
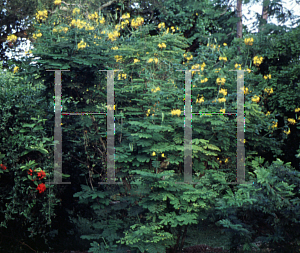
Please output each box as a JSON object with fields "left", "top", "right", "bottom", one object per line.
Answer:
{"left": 0, "top": 62, "right": 59, "bottom": 252}
